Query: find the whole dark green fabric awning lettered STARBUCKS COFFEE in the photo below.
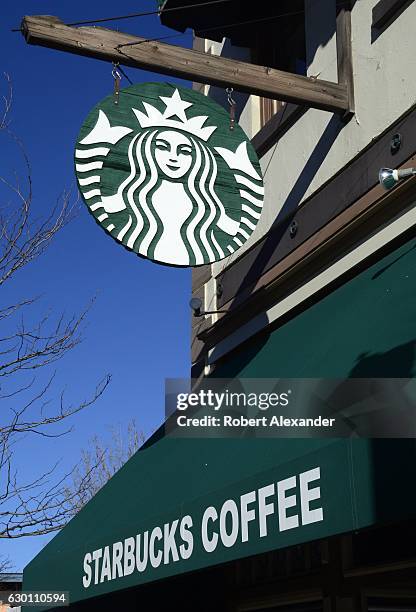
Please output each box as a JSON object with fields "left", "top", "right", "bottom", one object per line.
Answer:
{"left": 24, "top": 240, "right": 416, "bottom": 601}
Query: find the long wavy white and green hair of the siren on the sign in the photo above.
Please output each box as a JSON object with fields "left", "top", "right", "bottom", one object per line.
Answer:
{"left": 118, "top": 128, "right": 229, "bottom": 265}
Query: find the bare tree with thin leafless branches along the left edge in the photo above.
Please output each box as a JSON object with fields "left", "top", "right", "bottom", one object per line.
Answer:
{"left": 0, "top": 75, "right": 110, "bottom": 540}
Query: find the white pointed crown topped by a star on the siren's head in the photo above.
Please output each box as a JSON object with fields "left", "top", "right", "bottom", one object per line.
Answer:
{"left": 132, "top": 89, "right": 217, "bottom": 141}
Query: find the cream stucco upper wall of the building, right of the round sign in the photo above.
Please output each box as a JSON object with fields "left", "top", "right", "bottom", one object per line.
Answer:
{"left": 206, "top": 0, "right": 416, "bottom": 275}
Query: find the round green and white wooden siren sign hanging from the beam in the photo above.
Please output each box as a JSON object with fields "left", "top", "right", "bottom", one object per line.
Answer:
{"left": 75, "top": 83, "right": 264, "bottom": 266}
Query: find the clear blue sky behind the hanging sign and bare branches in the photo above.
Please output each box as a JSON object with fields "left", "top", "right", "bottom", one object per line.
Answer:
{"left": 0, "top": 0, "right": 191, "bottom": 571}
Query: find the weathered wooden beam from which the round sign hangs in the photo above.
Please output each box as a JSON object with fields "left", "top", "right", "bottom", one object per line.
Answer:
{"left": 21, "top": 15, "right": 349, "bottom": 113}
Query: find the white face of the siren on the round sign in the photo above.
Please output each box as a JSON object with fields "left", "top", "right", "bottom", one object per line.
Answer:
{"left": 155, "top": 130, "right": 192, "bottom": 179}
